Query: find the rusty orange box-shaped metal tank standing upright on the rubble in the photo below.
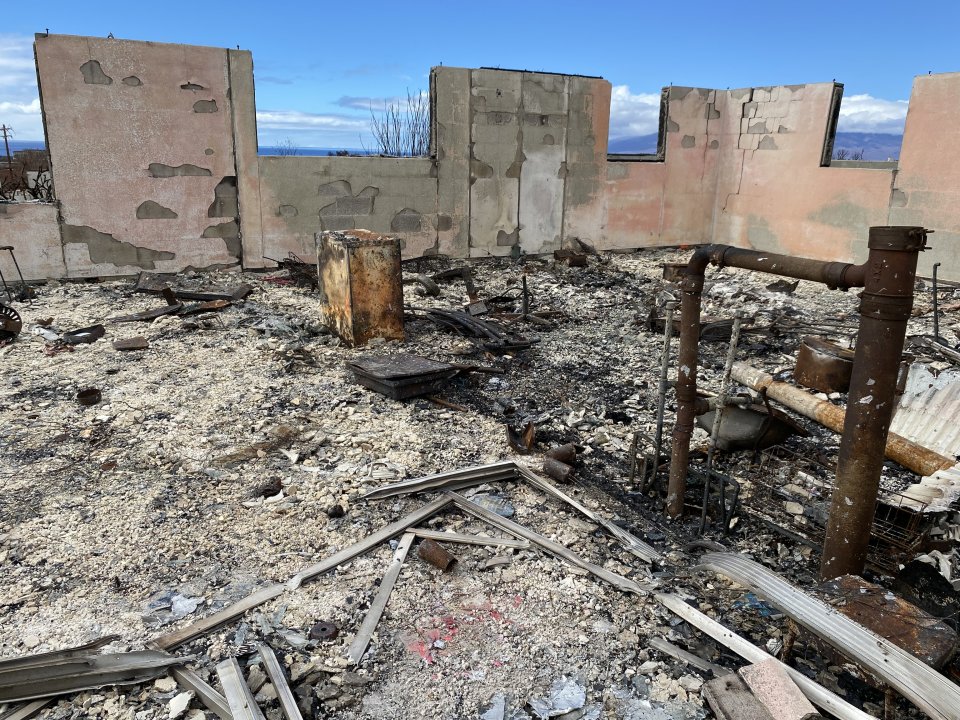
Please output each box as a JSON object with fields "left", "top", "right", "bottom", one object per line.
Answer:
{"left": 316, "top": 230, "right": 404, "bottom": 347}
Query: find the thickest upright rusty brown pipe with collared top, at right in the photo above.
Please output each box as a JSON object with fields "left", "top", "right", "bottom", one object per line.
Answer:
{"left": 820, "top": 227, "right": 927, "bottom": 579}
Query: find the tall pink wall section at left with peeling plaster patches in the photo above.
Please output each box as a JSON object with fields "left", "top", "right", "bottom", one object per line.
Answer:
{"left": 36, "top": 34, "right": 256, "bottom": 277}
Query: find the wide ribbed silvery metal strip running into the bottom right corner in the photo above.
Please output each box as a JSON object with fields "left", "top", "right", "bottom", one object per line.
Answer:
{"left": 698, "top": 553, "right": 960, "bottom": 720}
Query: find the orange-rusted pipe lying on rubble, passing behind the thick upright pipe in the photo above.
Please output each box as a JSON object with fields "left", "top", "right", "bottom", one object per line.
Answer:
{"left": 731, "top": 362, "right": 956, "bottom": 476}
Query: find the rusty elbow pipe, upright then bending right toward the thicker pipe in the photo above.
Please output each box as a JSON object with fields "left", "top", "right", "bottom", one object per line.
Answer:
{"left": 666, "top": 245, "right": 866, "bottom": 517}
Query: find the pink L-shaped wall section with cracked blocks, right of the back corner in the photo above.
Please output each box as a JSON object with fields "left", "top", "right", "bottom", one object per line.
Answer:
{"left": 712, "top": 83, "right": 894, "bottom": 262}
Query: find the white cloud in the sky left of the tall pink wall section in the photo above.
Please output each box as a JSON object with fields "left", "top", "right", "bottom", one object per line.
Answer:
{"left": 0, "top": 34, "right": 43, "bottom": 140}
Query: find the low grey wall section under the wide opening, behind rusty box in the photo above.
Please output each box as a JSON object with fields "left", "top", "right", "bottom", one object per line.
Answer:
{"left": 259, "top": 155, "right": 440, "bottom": 260}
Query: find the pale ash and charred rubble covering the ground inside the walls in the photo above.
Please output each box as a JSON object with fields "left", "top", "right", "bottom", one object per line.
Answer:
{"left": 0, "top": 251, "right": 956, "bottom": 720}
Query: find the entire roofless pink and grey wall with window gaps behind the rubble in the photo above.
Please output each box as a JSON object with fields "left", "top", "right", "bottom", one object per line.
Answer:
{"left": 13, "top": 35, "right": 960, "bottom": 279}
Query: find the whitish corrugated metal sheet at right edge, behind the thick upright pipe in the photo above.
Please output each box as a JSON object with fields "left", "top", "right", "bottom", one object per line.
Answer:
{"left": 890, "top": 363, "right": 960, "bottom": 458}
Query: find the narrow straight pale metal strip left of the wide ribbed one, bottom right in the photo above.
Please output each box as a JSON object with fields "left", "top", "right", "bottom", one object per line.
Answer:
{"left": 656, "top": 594, "right": 876, "bottom": 720}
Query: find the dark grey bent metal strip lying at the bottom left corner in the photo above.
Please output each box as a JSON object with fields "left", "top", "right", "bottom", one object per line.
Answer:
{"left": 0, "top": 650, "right": 193, "bottom": 702}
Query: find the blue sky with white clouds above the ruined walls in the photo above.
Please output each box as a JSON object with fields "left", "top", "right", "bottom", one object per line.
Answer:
{"left": 0, "top": 0, "right": 960, "bottom": 148}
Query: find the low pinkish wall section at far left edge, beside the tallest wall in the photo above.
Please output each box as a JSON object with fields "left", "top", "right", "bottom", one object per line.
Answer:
{"left": 0, "top": 203, "right": 66, "bottom": 282}
